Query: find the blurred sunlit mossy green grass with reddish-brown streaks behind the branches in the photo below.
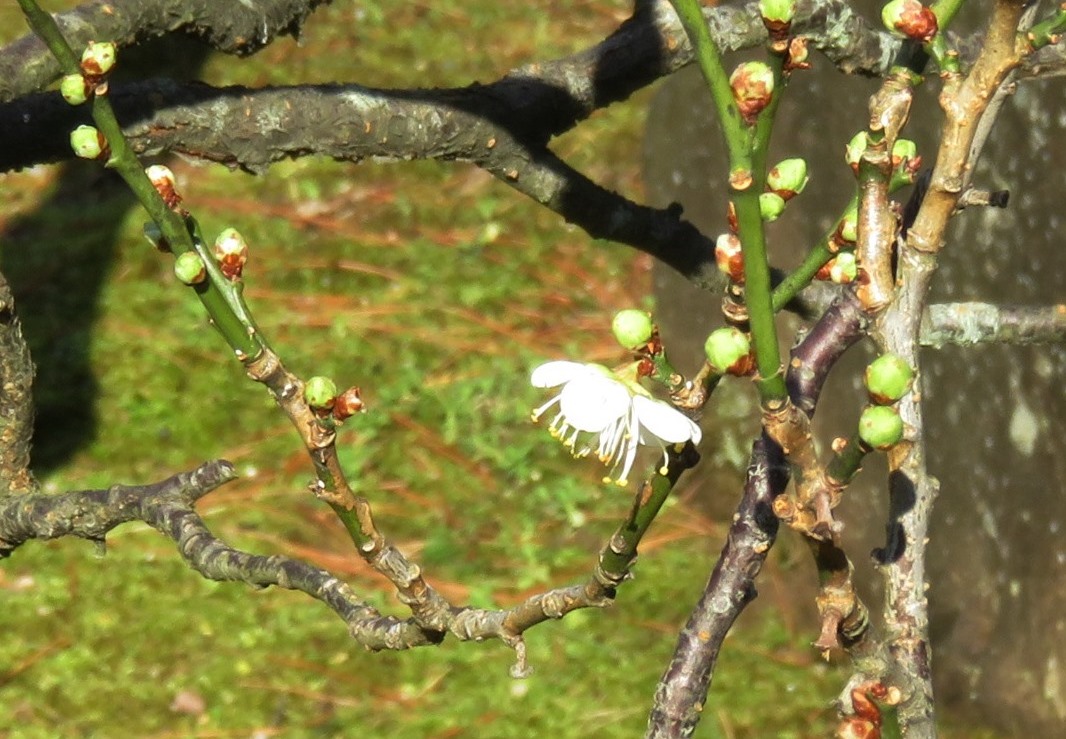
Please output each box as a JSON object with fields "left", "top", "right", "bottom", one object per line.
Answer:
{"left": 0, "top": 0, "right": 997, "bottom": 739}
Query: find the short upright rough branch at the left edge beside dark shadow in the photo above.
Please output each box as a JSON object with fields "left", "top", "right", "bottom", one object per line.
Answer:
{"left": 0, "top": 267, "right": 37, "bottom": 496}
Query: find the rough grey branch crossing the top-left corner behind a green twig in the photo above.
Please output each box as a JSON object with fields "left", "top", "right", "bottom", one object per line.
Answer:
{"left": 0, "top": 0, "right": 329, "bottom": 102}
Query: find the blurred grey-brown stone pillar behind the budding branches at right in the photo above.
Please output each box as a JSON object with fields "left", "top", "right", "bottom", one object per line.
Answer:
{"left": 645, "top": 27, "right": 1066, "bottom": 736}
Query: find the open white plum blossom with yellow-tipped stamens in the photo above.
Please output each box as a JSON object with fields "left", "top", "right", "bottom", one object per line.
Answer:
{"left": 530, "top": 362, "right": 701, "bottom": 485}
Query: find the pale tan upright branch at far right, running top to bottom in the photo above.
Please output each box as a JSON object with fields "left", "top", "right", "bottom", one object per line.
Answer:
{"left": 872, "top": 0, "right": 1024, "bottom": 738}
